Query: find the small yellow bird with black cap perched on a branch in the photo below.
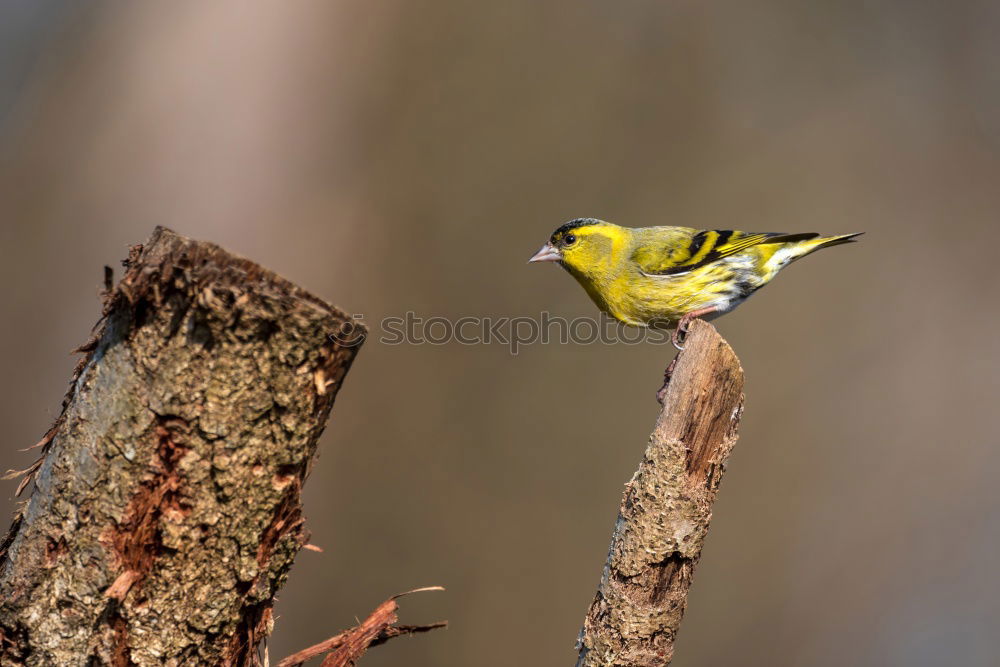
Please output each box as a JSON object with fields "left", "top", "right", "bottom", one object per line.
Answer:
{"left": 528, "top": 218, "right": 863, "bottom": 349}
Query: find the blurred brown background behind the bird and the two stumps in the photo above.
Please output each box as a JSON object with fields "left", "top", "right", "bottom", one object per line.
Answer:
{"left": 0, "top": 0, "right": 1000, "bottom": 667}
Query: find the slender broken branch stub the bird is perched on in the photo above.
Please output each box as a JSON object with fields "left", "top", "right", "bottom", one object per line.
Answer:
{"left": 577, "top": 320, "right": 743, "bottom": 667}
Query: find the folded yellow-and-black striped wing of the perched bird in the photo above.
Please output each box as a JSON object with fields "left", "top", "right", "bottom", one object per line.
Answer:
{"left": 632, "top": 229, "right": 819, "bottom": 276}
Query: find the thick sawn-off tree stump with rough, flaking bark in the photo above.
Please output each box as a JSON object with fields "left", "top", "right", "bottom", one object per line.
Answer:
{"left": 0, "top": 228, "right": 363, "bottom": 666}
